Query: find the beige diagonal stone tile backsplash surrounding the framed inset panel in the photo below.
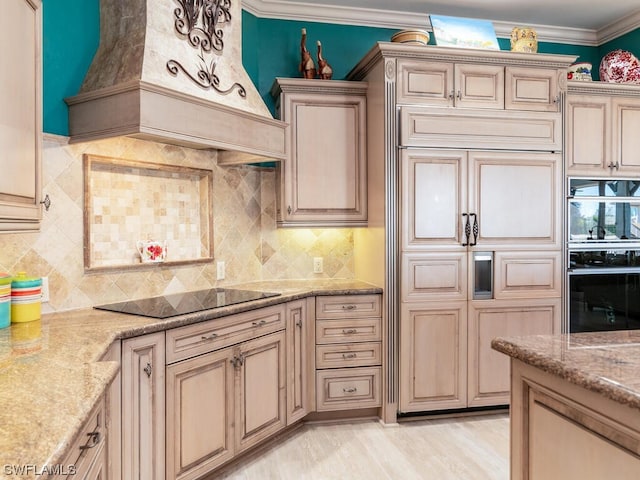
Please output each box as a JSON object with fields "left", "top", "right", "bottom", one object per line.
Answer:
{"left": 0, "top": 135, "right": 355, "bottom": 312}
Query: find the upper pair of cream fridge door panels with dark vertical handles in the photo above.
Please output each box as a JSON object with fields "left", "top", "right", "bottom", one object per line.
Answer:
{"left": 401, "top": 149, "right": 561, "bottom": 252}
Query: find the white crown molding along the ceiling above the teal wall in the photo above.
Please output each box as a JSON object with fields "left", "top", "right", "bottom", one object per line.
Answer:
{"left": 242, "top": 0, "right": 640, "bottom": 47}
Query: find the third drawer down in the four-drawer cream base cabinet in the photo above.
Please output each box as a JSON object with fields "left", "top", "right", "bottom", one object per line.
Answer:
{"left": 316, "top": 342, "right": 382, "bottom": 368}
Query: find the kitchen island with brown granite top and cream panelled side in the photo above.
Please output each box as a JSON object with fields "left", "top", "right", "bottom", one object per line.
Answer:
{"left": 492, "top": 331, "right": 640, "bottom": 480}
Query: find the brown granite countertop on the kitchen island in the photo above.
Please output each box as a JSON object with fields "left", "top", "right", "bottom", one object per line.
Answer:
{"left": 491, "top": 330, "right": 640, "bottom": 410}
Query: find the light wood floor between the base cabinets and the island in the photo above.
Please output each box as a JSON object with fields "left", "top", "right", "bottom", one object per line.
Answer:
{"left": 218, "top": 413, "right": 509, "bottom": 480}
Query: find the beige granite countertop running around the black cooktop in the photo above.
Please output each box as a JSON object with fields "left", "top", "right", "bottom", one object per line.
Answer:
{"left": 0, "top": 280, "right": 382, "bottom": 479}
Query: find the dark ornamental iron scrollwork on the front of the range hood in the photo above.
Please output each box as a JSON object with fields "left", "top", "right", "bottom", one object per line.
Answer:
{"left": 167, "top": 0, "right": 247, "bottom": 98}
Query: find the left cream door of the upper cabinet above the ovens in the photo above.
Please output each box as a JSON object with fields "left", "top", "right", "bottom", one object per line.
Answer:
{"left": 565, "top": 95, "right": 611, "bottom": 175}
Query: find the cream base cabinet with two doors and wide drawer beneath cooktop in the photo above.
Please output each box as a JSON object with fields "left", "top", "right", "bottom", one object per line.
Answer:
{"left": 166, "top": 304, "right": 284, "bottom": 479}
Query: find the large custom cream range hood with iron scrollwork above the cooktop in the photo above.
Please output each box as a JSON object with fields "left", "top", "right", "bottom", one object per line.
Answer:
{"left": 65, "top": 0, "right": 286, "bottom": 164}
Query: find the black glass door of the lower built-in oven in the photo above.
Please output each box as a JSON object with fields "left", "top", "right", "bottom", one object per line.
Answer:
{"left": 568, "top": 268, "right": 640, "bottom": 333}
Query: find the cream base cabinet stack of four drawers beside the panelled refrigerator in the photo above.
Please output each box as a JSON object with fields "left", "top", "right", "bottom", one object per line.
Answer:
{"left": 316, "top": 295, "right": 382, "bottom": 412}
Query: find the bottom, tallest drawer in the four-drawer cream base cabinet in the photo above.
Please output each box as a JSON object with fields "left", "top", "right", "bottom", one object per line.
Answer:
{"left": 316, "top": 367, "right": 382, "bottom": 412}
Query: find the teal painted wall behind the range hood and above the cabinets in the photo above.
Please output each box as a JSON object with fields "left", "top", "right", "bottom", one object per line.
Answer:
{"left": 43, "top": 4, "right": 640, "bottom": 135}
